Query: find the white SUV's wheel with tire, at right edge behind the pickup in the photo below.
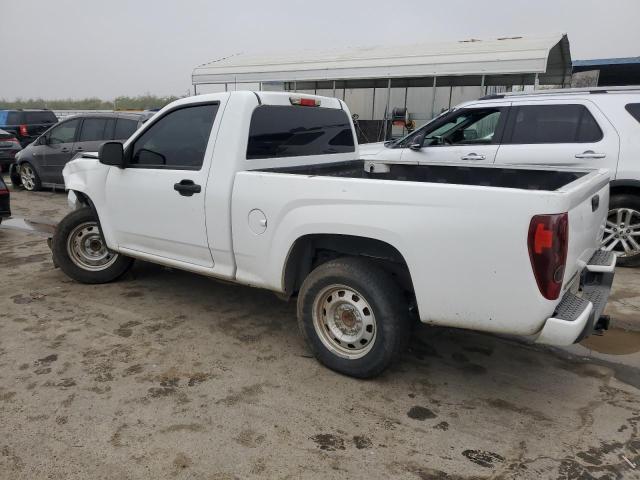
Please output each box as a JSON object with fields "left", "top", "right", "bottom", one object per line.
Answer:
{"left": 602, "top": 194, "right": 640, "bottom": 267}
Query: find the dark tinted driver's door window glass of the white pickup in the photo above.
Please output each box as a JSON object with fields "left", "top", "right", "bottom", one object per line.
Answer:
{"left": 129, "top": 103, "right": 218, "bottom": 170}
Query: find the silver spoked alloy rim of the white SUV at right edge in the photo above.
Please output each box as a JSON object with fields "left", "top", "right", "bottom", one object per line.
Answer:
{"left": 602, "top": 208, "right": 640, "bottom": 257}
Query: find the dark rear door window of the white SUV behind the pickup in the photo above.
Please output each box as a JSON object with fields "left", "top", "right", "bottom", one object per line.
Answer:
{"left": 503, "top": 104, "right": 603, "bottom": 145}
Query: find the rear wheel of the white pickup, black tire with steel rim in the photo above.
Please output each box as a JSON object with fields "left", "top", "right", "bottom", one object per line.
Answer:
{"left": 298, "top": 258, "right": 410, "bottom": 378}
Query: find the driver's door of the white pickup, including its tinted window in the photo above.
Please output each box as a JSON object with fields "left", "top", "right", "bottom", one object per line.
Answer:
{"left": 106, "top": 102, "right": 219, "bottom": 268}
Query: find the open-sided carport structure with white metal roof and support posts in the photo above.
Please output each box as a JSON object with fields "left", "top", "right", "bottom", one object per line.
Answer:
{"left": 192, "top": 33, "right": 572, "bottom": 140}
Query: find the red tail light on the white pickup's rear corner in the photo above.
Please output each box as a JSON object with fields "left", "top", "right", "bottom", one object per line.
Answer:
{"left": 527, "top": 213, "right": 569, "bottom": 300}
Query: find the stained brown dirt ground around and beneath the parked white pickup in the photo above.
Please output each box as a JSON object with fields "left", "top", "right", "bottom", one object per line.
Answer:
{"left": 0, "top": 185, "right": 640, "bottom": 480}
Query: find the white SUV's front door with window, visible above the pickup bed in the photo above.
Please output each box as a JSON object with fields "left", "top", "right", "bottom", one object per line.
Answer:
{"left": 402, "top": 103, "right": 508, "bottom": 164}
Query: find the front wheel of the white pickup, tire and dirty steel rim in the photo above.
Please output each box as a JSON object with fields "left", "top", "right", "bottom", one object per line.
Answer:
{"left": 51, "top": 207, "right": 133, "bottom": 284}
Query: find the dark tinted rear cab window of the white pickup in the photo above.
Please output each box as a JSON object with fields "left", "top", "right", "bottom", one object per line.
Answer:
{"left": 247, "top": 105, "right": 355, "bottom": 160}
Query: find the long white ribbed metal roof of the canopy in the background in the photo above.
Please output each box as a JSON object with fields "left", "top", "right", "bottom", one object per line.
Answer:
{"left": 192, "top": 34, "right": 571, "bottom": 85}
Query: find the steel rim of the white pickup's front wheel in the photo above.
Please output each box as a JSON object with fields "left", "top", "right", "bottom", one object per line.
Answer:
{"left": 67, "top": 222, "right": 118, "bottom": 272}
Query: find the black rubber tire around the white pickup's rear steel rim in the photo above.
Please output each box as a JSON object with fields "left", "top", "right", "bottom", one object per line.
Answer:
{"left": 298, "top": 257, "right": 411, "bottom": 378}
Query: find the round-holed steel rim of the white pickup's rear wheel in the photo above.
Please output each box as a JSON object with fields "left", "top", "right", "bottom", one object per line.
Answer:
{"left": 313, "top": 284, "right": 377, "bottom": 360}
